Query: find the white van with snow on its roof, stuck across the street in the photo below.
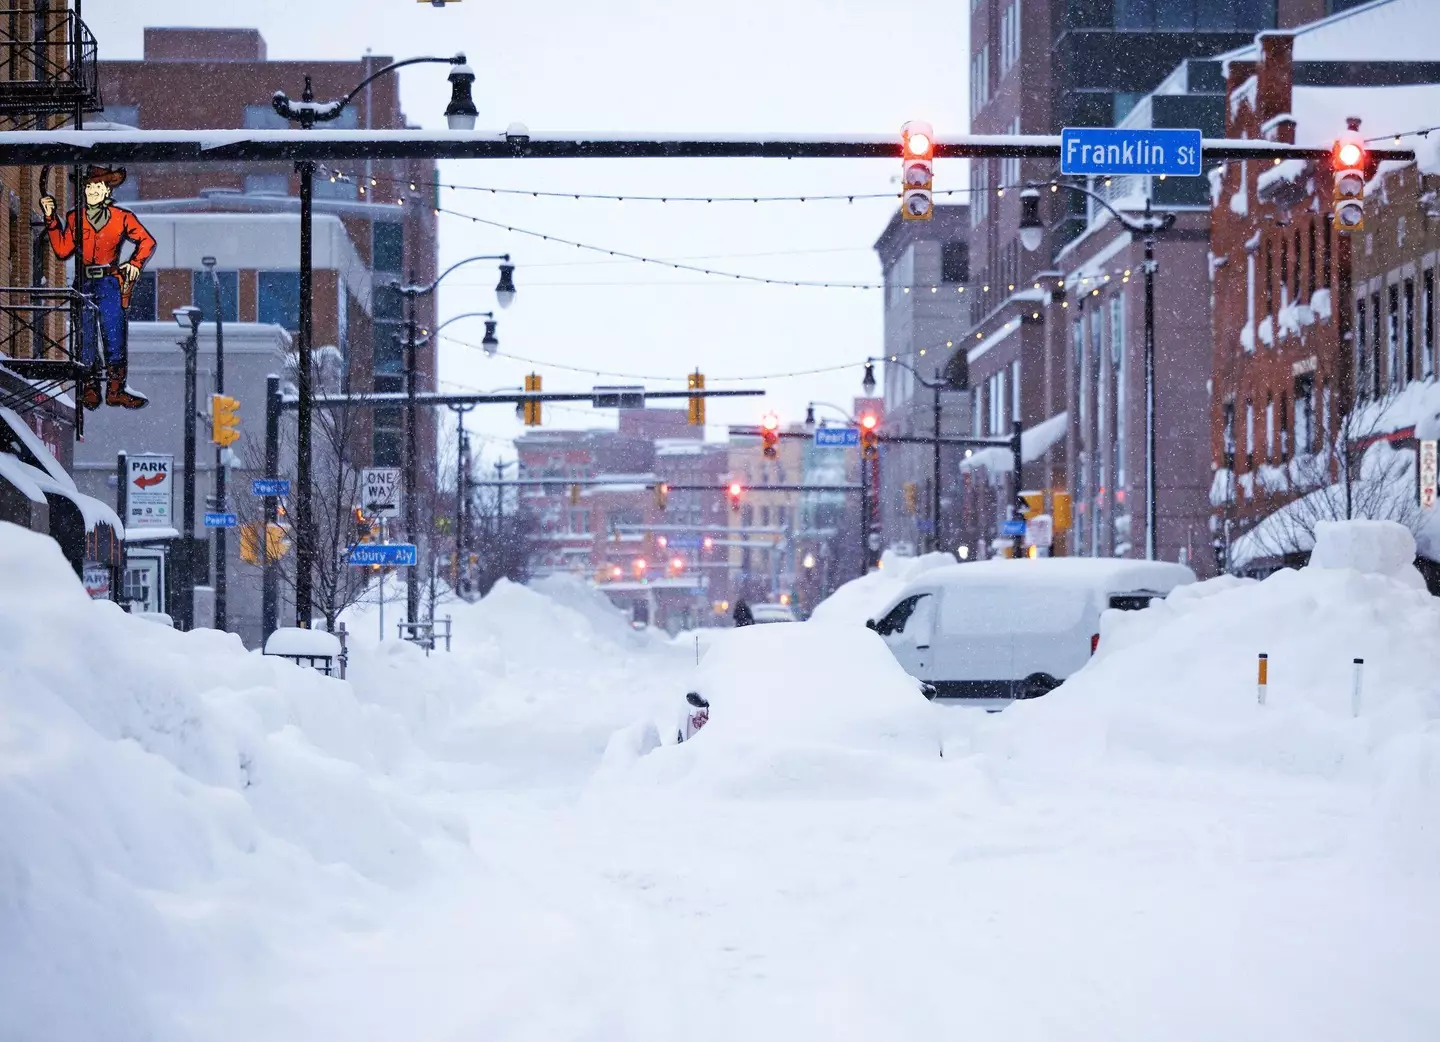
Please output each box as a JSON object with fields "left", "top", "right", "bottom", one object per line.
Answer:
{"left": 865, "top": 557, "right": 1195, "bottom": 705}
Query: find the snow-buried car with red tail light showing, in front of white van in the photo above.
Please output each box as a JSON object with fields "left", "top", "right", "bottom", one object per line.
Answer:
{"left": 675, "top": 622, "right": 939, "bottom": 756}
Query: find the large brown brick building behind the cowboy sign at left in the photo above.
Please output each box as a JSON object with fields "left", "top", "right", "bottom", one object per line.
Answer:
{"left": 99, "top": 27, "right": 438, "bottom": 481}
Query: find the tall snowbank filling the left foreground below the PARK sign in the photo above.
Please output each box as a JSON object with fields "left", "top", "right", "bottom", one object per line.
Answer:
{"left": 0, "top": 524, "right": 468, "bottom": 1042}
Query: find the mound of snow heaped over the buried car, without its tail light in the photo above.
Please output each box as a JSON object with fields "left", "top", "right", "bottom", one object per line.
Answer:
{"left": 611, "top": 622, "right": 940, "bottom": 797}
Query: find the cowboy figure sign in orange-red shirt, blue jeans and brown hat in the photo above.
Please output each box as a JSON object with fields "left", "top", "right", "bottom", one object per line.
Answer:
{"left": 40, "top": 167, "right": 156, "bottom": 409}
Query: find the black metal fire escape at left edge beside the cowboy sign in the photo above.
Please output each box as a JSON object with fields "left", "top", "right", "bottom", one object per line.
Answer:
{"left": 0, "top": 0, "right": 101, "bottom": 436}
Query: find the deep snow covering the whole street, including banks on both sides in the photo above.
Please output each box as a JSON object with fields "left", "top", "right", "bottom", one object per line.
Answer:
{"left": 0, "top": 527, "right": 1440, "bottom": 1042}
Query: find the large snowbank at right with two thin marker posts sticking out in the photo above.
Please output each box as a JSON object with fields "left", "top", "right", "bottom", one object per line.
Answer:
{"left": 979, "top": 521, "right": 1440, "bottom": 856}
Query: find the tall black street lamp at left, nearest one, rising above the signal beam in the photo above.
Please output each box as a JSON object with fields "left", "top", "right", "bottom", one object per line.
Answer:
{"left": 271, "top": 55, "right": 478, "bottom": 629}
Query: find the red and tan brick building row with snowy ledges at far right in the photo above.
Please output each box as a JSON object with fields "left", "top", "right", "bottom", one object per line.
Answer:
{"left": 1210, "top": 0, "right": 1440, "bottom": 570}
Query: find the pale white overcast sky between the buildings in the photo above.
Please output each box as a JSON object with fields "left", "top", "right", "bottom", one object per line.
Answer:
{"left": 84, "top": 0, "right": 968, "bottom": 463}
